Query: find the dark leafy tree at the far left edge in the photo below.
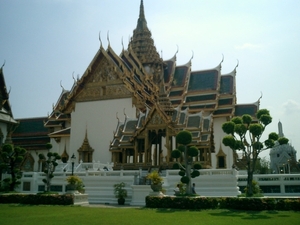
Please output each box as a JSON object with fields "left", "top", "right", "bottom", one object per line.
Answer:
{"left": 0, "top": 144, "right": 27, "bottom": 191}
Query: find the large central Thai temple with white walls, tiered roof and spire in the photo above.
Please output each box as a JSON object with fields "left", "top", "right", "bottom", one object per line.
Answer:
{"left": 15, "top": 1, "right": 259, "bottom": 171}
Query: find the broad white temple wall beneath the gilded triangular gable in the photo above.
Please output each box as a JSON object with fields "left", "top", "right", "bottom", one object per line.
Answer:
{"left": 69, "top": 98, "right": 136, "bottom": 163}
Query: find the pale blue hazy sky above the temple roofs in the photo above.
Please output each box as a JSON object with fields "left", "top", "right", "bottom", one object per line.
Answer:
{"left": 0, "top": 0, "right": 300, "bottom": 158}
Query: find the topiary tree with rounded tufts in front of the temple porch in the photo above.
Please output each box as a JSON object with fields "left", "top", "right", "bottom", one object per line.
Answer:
{"left": 171, "top": 130, "right": 201, "bottom": 195}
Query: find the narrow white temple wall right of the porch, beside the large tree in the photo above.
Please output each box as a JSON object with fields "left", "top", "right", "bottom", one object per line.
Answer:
{"left": 211, "top": 117, "right": 233, "bottom": 169}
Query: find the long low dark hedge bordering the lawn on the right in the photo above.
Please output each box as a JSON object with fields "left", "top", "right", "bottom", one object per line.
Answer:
{"left": 146, "top": 196, "right": 300, "bottom": 211}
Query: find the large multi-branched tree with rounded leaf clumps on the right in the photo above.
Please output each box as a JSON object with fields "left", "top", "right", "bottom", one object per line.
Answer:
{"left": 222, "top": 109, "right": 289, "bottom": 197}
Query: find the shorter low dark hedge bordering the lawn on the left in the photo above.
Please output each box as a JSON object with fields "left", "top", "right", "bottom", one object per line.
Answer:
{"left": 0, "top": 194, "right": 74, "bottom": 205}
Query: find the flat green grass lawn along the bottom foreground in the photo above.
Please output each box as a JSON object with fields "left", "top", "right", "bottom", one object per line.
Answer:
{"left": 0, "top": 204, "right": 300, "bottom": 225}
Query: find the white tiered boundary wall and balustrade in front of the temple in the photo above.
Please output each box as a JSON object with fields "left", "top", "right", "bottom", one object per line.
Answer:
{"left": 3, "top": 168, "right": 300, "bottom": 205}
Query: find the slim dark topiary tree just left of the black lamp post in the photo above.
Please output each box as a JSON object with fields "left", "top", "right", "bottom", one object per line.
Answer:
{"left": 39, "top": 143, "right": 61, "bottom": 192}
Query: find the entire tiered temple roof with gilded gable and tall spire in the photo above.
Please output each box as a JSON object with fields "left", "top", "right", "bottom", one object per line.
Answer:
{"left": 46, "top": 1, "right": 259, "bottom": 169}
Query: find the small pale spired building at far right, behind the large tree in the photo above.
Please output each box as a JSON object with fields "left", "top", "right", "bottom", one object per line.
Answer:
{"left": 270, "top": 121, "right": 300, "bottom": 173}
